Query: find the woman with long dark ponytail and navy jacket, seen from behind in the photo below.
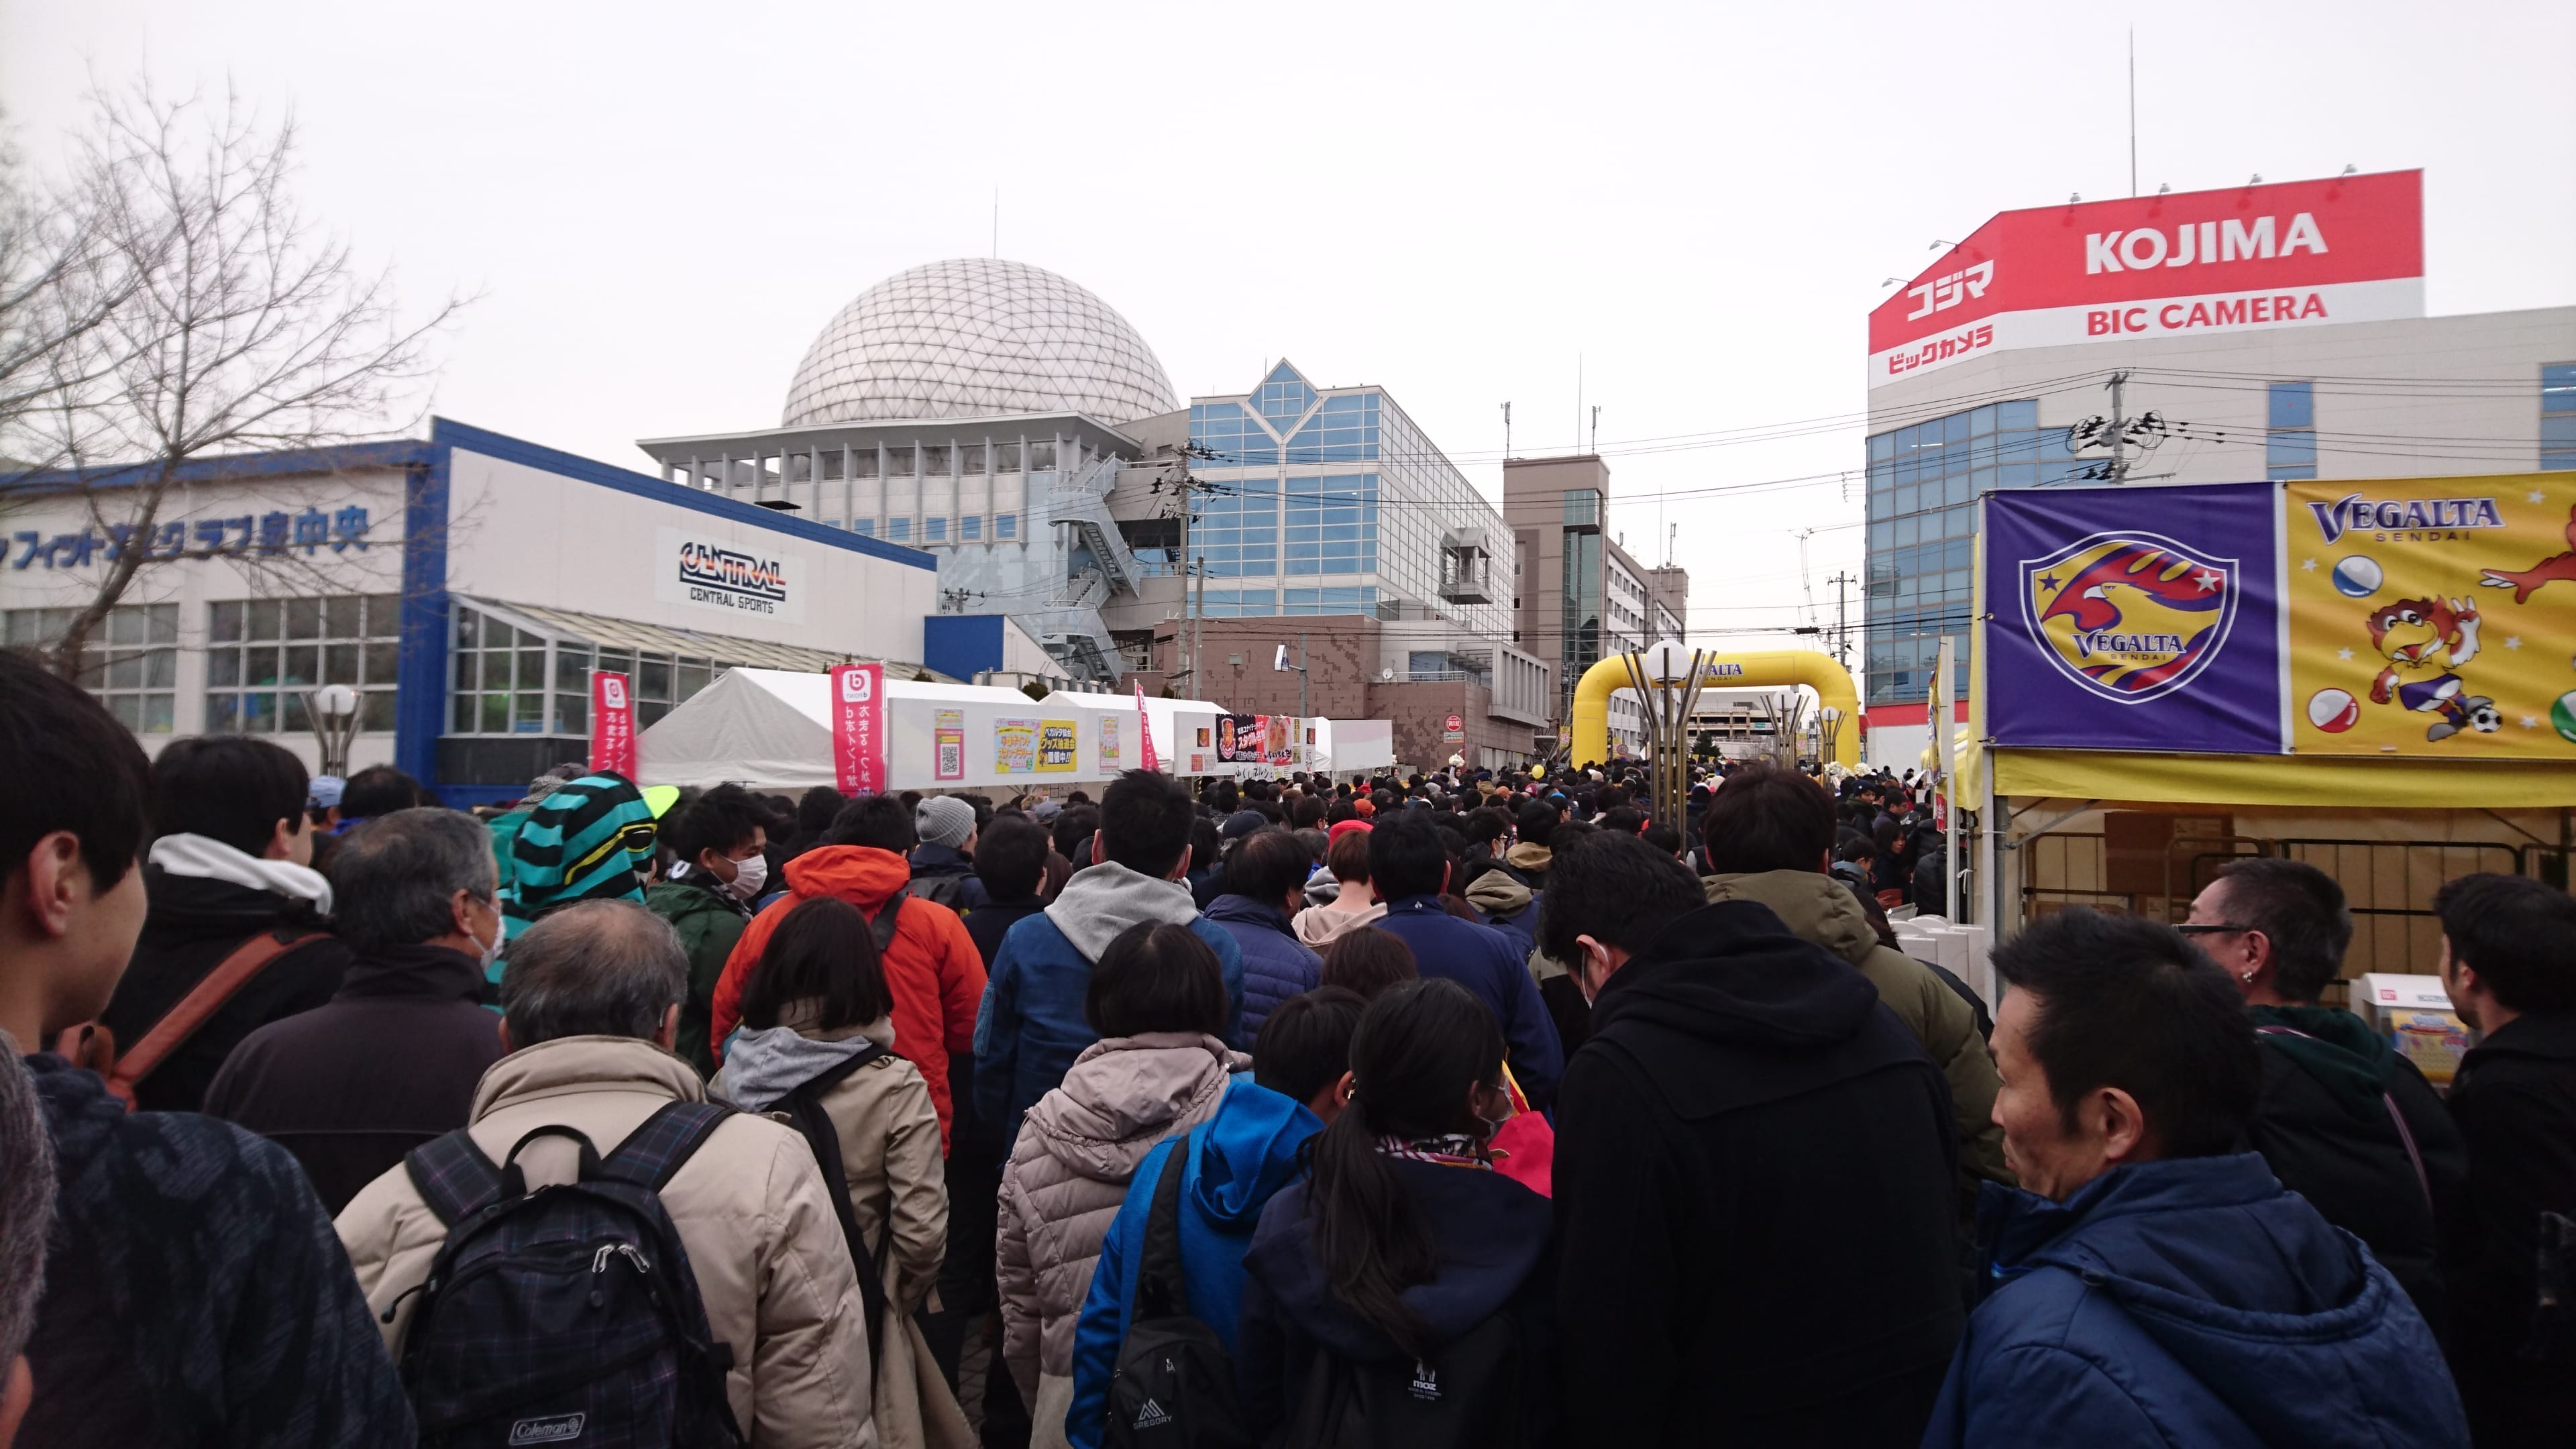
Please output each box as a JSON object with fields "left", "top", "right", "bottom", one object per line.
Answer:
{"left": 1236, "top": 977, "right": 1554, "bottom": 1446}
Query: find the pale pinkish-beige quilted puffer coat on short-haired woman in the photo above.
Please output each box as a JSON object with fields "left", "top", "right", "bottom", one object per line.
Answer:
{"left": 994, "top": 1031, "right": 1252, "bottom": 1403}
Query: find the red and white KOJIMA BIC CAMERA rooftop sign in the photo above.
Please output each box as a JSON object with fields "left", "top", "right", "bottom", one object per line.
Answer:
{"left": 1870, "top": 170, "right": 2424, "bottom": 387}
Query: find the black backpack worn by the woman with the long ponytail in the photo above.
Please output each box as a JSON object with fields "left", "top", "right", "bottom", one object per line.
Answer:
{"left": 1280, "top": 1309, "right": 1530, "bottom": 1449}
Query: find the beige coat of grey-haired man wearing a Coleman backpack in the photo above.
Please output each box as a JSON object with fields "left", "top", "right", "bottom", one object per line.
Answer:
{"left": 337, "top": 1036, "right": 876, "bottom": 1449}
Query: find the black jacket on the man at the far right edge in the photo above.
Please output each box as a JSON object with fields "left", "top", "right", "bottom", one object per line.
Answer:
{"left": 2450, "top": 1011, "right": 2576, "bottom": 1446}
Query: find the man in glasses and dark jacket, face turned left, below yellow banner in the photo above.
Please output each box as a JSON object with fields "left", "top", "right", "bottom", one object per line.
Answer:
{"left": 2182, "top": 856, "right": 2468, "bottom": 1336}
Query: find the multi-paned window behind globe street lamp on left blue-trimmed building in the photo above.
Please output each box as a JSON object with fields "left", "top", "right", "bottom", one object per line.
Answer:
{"left": 206, "top": 593, "right": 402, "bottom": 735}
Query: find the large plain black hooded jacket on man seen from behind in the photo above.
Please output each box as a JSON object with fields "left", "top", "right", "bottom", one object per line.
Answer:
{"left": 1556, "top": 900, "right": 1963, "bottom": 1446}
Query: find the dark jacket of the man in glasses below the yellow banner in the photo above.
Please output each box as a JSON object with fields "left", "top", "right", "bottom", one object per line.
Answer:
{"left": 2246, "top": 1006, "right": 2468, "bottom": 1338}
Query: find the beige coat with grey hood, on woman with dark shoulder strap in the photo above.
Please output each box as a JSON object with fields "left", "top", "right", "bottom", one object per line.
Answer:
{"left": 708, "top": 1016, "right": 974, "bottom": 1449}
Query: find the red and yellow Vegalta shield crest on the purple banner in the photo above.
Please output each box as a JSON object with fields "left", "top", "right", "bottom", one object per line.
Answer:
{"left": 2022, "top": 531, "right": 2239, "bottom": 704}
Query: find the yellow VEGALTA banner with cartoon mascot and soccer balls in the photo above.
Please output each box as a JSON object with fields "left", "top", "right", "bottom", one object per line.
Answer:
{"left": 2282, "top": 472, "right": 2576, "bottom": 761}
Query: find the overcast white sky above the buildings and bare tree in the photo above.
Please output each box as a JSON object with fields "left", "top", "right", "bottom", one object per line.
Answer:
{"left": 0, "top": 0, "right": 2576, "bottom": 642}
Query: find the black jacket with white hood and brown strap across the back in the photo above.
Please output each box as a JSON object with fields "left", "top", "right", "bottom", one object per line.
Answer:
{"left": 98, "top": 866, "right": 347, "bottom": 1112}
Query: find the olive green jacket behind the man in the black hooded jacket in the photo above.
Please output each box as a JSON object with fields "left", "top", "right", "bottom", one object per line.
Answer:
{"left": 1700, "top": 871, "right": 2015, "bottom": 1201}
